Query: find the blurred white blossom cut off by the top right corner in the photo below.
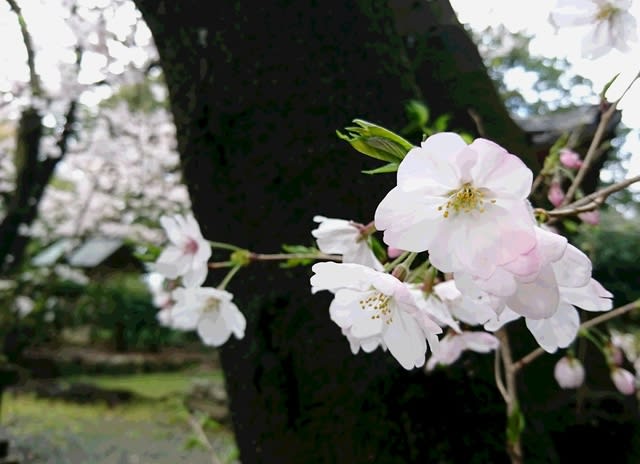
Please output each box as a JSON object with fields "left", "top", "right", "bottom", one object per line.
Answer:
{"left": 549, "top": 0, "right": 638, "bottom": 59}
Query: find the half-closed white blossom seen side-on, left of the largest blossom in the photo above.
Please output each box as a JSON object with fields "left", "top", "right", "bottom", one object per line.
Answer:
{"left": 311, "top": 216, "right": 384, "bottom": 271}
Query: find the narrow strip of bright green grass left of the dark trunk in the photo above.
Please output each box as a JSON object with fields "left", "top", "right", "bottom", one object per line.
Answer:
{"left": 64, "top": 371, "right": 223, "bottom": 399}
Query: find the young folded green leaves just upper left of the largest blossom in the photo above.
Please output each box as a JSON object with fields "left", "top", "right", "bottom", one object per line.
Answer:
{"left": 336, "top": 119, "right": 414, "bottom": 163}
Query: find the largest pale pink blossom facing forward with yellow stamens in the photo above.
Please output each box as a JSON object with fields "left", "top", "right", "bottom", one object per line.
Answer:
{"left": 375, "top": 132, "right": 535, "bottom": 277}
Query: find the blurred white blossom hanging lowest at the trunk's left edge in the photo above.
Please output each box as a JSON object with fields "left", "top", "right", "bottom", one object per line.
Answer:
{"left": 169, "top": 287, "right": 247, "bottom": 346}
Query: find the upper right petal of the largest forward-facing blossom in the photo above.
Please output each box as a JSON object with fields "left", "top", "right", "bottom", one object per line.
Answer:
{"left": 469, "top": 139, "right": 533, "bottom": 200}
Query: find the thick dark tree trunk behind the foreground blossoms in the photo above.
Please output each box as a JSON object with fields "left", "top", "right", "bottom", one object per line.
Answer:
{"left": 136, "top": 0, "right": 636, "bottom": 464}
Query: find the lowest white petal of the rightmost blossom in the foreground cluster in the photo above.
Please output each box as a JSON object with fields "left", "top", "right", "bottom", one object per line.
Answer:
{"left": 526, "top": 302, "right": 580, "bottom": 353}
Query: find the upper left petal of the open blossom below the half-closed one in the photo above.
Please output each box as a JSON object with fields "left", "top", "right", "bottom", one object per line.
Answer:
{"left": 311, "top": 263, "right": 376, "bottom": 293}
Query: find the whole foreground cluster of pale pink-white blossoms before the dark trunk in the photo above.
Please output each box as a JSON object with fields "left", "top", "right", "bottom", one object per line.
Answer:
{"left": 311, "top": 132, "right": 612, "bottom": 370}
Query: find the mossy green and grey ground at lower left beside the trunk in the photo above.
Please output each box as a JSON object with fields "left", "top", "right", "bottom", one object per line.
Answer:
{"left": 2, "top": 372, "right": 237, "bottom": 464}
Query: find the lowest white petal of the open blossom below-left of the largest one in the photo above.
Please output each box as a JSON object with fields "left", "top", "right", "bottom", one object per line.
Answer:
{"left": 383, "top": 312, "right": 427, "bottom": 370}
